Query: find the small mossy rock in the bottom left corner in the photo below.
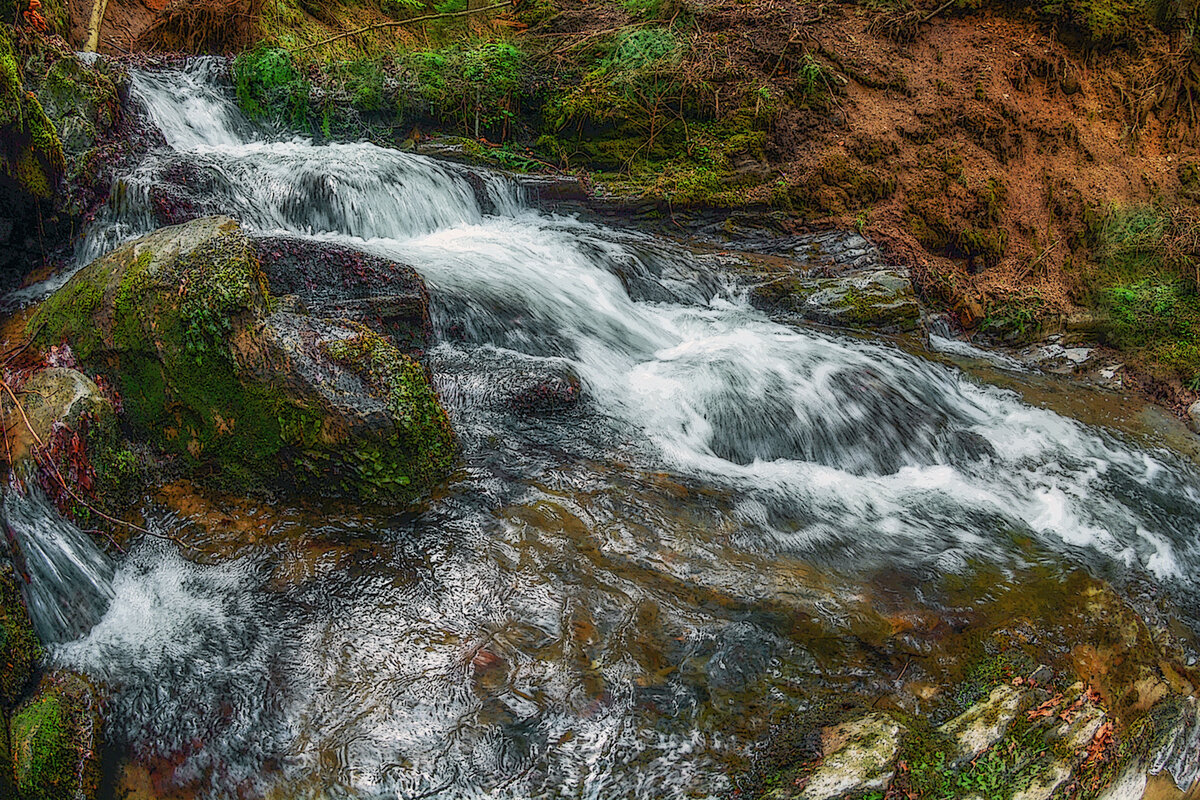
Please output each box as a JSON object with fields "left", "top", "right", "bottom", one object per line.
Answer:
{"left": 10, "top": 672, "right": 103, "bottom": 800}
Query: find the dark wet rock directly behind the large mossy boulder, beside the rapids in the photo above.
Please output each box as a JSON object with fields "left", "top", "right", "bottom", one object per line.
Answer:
{"left": 253, "top": 236, "right": 432, "bottom": 350}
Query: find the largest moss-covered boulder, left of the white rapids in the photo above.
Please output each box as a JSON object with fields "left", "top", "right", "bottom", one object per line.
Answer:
{"left": 30, "top": 217, "right": 455, "bottom": 503}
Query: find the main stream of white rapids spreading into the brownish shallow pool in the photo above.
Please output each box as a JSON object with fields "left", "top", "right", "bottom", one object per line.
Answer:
{"left": 11, "top": 60, "right": 1200, "bottom": 798}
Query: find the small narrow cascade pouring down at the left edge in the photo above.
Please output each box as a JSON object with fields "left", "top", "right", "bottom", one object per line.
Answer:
{"left": 4, "top": 488, "right": 113, "bottom": 643}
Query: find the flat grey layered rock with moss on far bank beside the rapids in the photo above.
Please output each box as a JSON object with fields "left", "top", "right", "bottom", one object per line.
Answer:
{"left": 750, "top": 269, "right": 920, "bottom": 331}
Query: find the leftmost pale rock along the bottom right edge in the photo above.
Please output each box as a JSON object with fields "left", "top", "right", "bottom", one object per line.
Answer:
{"left": 787, "top": 714, "right": 902, "bottom": 800}
